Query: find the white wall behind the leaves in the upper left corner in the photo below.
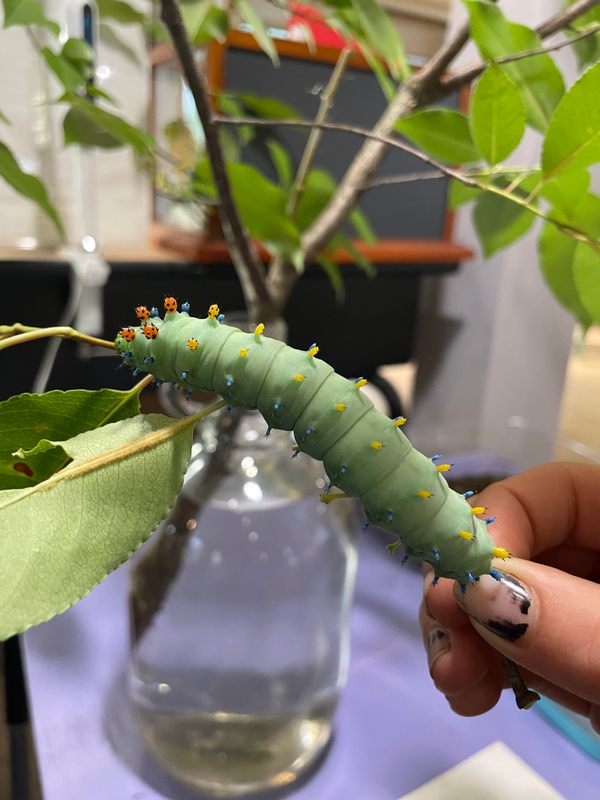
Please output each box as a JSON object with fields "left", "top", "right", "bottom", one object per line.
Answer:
{"left": 0, "top": 0, "right": 151, "bottom": 247}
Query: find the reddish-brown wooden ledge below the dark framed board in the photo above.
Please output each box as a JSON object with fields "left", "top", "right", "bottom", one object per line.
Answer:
{"left": 151, "top": 223, "right": 473, "bottom": 264}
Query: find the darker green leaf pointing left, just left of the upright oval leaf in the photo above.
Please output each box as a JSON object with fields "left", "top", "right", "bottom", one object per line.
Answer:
{"left": 394, "top": 108, "right": 480, "bottom": 164}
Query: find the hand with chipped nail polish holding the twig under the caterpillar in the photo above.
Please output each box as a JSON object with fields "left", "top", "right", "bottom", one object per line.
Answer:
{"left": 420, "top": 463, "right": 600, "bottom": 732}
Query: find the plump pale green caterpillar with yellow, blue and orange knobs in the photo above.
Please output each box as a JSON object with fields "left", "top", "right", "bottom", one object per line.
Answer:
{"left": 116, "top": 297, "right": 509, "bottom": 586}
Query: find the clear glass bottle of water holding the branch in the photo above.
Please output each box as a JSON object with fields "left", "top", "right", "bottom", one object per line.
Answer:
{"left": 130, "top": 318, "right": 360, "bottom": 797}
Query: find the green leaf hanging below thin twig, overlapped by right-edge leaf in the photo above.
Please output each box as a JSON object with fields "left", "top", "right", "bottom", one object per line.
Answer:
{"left": 538, "top": 222, "right": 592, "bottom": 329}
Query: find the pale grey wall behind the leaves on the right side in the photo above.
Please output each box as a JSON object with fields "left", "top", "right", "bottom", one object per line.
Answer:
{"left": 410, "top": 0, "right": 574, "bottom": 467}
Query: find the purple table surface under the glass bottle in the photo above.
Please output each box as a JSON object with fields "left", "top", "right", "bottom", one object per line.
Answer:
{"left": 24, "top": 532, "right": 600, "bottom": 800}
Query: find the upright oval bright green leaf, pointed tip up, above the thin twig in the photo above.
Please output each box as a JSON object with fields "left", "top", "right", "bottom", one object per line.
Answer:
{"left": 469, "top": 64, "right": 525, "bottom": 166}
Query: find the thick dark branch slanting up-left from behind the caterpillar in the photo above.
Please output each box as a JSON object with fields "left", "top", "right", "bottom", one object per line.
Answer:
{"left": 161, "top": 0, "right": 275, "bottom": 319}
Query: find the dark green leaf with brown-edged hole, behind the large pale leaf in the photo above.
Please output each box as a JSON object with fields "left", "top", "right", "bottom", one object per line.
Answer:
{"left": 0, "top": 389, "right": 139, "bottom": 490}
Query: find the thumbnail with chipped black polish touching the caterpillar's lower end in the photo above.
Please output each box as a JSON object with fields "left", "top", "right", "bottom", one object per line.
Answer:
{"left": 454, "top": 570, "right": 531, "bottom": 642}
